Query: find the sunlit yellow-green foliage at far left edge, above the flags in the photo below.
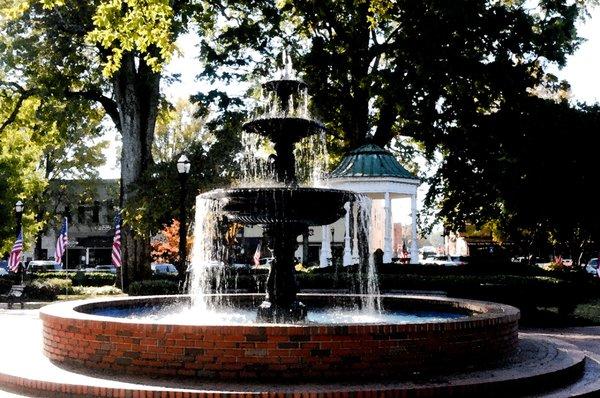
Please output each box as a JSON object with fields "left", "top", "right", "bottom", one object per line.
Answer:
{"left": 0, "top": 4, "right": 106, "bottom": 252}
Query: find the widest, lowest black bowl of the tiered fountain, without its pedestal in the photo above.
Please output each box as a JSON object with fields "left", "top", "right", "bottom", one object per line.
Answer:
{"left": 200, "top": 187, "right": 355, "bottom": 225}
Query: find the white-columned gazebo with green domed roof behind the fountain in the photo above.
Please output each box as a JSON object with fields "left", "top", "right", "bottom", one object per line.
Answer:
{"left": 320, "top": 144, "right": 421, "bottom": 266}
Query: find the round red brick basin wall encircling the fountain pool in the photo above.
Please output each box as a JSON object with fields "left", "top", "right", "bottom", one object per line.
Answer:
{"left": 41, "top": 294, "right": 519, "bottom": 381}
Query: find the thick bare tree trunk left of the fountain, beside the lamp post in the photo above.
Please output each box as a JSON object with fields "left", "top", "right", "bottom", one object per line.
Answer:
{"left": 113, "top": 55, "right": 160, "bottom": 289}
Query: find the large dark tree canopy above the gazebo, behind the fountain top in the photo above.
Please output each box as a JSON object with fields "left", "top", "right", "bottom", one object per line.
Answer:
{"left": 201, "top": 0, "right": 581, "bottom": 152}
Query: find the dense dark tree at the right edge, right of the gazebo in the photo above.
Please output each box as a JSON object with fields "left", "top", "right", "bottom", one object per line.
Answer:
{"left": 422, "top": 97, "right": 600, "bottom": 258}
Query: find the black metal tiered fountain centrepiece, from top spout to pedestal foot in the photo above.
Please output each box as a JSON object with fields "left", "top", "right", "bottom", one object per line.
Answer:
{"left": 201, "top": 53, "right": 354, "bottom": 322}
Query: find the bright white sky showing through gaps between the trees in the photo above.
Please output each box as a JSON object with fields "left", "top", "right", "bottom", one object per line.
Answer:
{"left": 99, "top": 7, "right": 600, "bottom": 222}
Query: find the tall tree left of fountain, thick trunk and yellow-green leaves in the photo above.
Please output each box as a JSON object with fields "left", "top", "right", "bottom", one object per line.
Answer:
{"left": 2, "top": 0, "right": 201, "bottom": 285}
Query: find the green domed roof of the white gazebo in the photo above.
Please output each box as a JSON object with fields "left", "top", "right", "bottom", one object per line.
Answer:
{"left": 329, "top": 144, "right": 418, "bottom": 180}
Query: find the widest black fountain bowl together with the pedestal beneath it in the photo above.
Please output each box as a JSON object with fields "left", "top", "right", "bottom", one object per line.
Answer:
{"left": 200, "top": 187, "right": 355, "bottom": 322}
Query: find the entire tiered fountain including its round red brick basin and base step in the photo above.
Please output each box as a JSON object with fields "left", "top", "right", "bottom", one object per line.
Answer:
{"left": 16, "top": 53, "right": 598, "bottom": 398}
